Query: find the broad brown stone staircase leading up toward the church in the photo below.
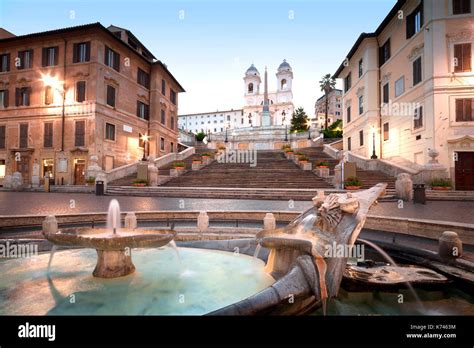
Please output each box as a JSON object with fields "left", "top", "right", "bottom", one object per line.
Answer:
{"left": 163, "top": 151, "right": 332, "bottom": 189}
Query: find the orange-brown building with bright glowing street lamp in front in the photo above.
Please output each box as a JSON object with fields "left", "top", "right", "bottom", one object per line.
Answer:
{"left": 0, "top": 23, "right": 184, "bottom": 185}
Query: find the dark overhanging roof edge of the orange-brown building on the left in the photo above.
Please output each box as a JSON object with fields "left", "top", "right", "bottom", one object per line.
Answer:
{"left": 0, "top": 22, "right": 185, "bottom": 92}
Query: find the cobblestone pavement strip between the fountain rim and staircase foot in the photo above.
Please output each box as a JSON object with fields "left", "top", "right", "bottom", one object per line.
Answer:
{"left": 0, "top": 192, "right": 474, "bottom": 224}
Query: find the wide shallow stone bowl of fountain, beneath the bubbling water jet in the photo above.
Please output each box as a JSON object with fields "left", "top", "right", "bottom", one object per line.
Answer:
{"left": 43, "top": 227, "right": 176, "bottom": 251}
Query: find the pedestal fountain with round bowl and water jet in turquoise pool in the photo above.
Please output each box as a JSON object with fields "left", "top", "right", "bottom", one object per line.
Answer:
{"left": 43, "top": 199, "right": 176, "bottom": 278}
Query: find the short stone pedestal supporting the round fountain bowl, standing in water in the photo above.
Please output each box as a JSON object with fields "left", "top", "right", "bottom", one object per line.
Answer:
{"left": 92, "top": 249, "right": 135, "bottom": 278}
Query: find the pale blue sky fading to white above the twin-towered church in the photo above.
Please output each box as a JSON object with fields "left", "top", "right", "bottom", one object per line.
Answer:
{"left": 0, "top": 0, "right": 396, "bottom": 114}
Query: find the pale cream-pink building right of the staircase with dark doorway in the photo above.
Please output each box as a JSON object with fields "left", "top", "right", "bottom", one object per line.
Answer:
{"left": 334, "top": 0, "right": 474, "bottom": 190}
